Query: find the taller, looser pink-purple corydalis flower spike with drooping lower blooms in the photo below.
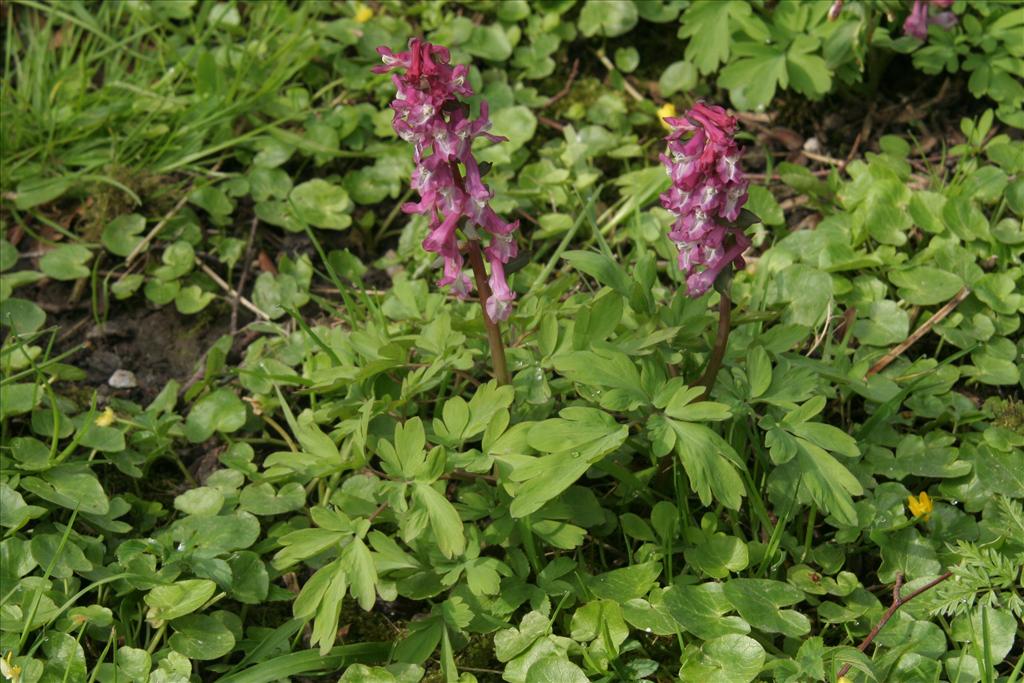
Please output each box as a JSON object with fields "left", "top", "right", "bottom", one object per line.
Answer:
{"left": 374, "top": 38, "right": 519, "bottom": 321}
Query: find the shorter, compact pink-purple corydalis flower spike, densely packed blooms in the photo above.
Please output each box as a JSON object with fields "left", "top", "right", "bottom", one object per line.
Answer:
{"left": 660, "top": 102, "right": 751, "bottom": 297}
